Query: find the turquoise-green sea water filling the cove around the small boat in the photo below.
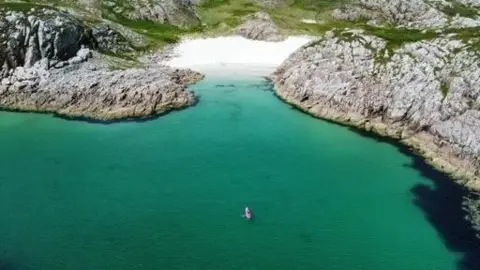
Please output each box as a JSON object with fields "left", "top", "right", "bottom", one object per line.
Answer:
{"left": 0, "top": 79, "right": 470, "bottom": 270}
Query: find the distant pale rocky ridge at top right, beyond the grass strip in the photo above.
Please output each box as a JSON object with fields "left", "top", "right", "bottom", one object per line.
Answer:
{"left": 333, "top": 0, "right": 480, "bottom": 29}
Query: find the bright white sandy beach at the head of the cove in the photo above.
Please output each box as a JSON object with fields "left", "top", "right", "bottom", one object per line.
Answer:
{"left": 165, "top": 36, "right": 311, "bottom": 76}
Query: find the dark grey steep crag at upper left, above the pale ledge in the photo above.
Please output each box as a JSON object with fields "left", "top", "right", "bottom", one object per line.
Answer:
{"left": 0, "top": 10, "right": 88, "bottom": 77}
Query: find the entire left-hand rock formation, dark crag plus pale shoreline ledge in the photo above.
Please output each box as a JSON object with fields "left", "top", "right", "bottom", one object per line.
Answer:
{"left": 0, "top": 9, "right": 202, "bottom": 120}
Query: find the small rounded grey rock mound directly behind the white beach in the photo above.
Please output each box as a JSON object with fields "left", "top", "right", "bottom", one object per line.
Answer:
{"left": 236, "top": 12, "right": 285, "bottom": 41}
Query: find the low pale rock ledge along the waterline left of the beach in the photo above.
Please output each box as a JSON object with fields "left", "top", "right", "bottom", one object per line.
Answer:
{"left": 0, "top": 50, "right": 203, "bottom": 120}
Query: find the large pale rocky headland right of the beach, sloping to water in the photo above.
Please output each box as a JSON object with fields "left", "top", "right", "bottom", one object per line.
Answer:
{"left": 271, "top": 30, "right": 480, "bottom": 189}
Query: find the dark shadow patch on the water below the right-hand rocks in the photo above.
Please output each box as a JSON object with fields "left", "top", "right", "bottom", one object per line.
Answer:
{"left": 349, "top": 127, "right": 480, "bottom": 270}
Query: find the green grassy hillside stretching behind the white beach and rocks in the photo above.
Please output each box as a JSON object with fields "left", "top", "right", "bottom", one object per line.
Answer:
{"left": 0, "top": 0, "right": 480, "bottom": 61}
